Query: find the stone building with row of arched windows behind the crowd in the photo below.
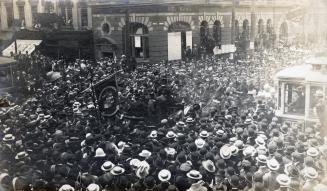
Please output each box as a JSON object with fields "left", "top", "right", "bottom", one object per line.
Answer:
{"left": 89, "top": 0, "right": 308, "bottom": 62}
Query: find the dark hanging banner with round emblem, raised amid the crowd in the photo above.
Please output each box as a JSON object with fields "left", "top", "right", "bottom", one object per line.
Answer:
{"left": 93, "top": 75, "right": 119, "bottom": 117}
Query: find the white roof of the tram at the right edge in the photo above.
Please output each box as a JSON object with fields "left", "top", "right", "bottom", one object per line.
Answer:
{"left": 275, "top": 64, "right": 327, "bottom": 83}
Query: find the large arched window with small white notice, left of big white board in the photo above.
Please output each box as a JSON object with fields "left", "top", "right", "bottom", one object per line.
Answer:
{"left": 122, "top": 23, "right": 149, "bottom": 59}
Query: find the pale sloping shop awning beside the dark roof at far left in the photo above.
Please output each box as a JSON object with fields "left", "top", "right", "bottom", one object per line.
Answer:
{"left": 2, "top": 39, "right": 42, "bottom": 57}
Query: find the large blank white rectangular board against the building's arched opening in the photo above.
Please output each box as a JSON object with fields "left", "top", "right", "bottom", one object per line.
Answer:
{"left": 168, "top": 32, "right": 182, "bottom": 60}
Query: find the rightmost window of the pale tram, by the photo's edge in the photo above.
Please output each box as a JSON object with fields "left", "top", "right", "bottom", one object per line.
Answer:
{"left": 309, "top": 86, "right": 324, "bottom": 117}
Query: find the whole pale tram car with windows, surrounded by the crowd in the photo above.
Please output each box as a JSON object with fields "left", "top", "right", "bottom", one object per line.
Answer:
{"left": 275, "top": 55, "right": 327, "bottom": 127}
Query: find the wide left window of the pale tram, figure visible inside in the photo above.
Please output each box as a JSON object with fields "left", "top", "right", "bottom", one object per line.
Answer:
{"left": 284, "top": 84, "right": 305, "bottom": 115}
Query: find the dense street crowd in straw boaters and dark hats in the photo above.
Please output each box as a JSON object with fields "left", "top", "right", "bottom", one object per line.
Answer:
{"left": 0, "top": 47, "right": 327, "bottom": 191}
